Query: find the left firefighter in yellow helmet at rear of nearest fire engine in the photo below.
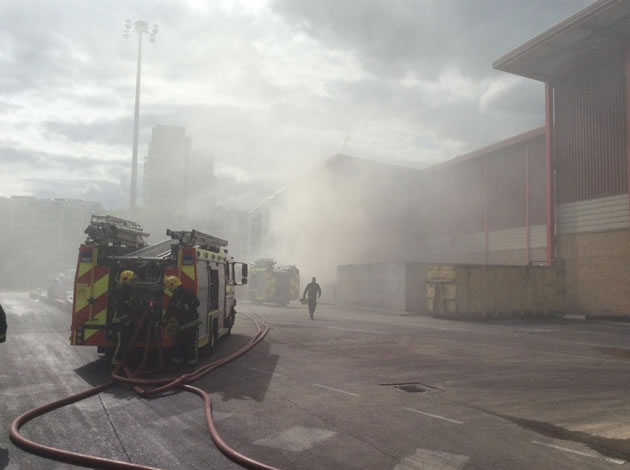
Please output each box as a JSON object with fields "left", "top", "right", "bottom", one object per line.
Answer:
{"left": 112, "top": 270, "right": 137, "bottom": 366}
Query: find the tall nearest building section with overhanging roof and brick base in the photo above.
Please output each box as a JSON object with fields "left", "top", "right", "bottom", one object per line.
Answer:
{"left": 494, "top": 0, "right": 630, "bottom": 316}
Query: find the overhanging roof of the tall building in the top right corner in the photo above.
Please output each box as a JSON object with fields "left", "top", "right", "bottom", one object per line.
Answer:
{"left": 493, "top": 0, "right": 630, "bottom": 81}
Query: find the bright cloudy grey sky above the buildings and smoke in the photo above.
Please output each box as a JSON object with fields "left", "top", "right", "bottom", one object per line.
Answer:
{"left": 0, "top": 0, "right": 592, "bottom": 207}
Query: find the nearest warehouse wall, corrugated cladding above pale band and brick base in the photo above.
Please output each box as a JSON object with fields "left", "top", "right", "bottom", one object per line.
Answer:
{"left": 552, "top": 51, "right": 630, "bottom": 317}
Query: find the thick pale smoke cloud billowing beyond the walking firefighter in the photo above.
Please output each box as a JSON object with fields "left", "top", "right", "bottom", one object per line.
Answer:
{"left": 250, "top": 155, "right": 419, "bottom": 283}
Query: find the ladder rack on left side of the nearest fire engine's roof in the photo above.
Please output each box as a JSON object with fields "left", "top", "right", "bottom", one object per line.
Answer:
{"left": 85, "top": 215, "right": 149, "bottom": 249}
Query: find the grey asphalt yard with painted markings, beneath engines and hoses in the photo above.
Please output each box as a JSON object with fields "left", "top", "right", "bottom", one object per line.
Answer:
{"left": 0, "top": 292, "right": 630, "bottom": 470}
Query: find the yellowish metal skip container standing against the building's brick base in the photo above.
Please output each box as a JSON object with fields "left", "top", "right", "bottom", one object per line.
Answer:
{"left": 426, "top": 264, "right": 565, "bottom": 319}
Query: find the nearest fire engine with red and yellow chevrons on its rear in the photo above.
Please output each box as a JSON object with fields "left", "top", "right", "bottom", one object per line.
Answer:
{"left": 70, "top": 216, "right": 248, "bottom": 353}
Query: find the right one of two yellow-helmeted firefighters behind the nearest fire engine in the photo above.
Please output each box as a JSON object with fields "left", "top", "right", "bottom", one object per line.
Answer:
{"left": 164, "top": 276, "right": 201, "bottom": 365}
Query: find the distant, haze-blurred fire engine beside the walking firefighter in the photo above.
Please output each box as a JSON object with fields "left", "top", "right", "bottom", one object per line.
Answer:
{"left": 249, "top": 259, "right": 300, "bottom": 306}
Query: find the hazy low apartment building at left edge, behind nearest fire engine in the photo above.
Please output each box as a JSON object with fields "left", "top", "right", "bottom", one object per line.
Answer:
{"left": 0, "top": 196, "right": 103, "bottom": 289}
